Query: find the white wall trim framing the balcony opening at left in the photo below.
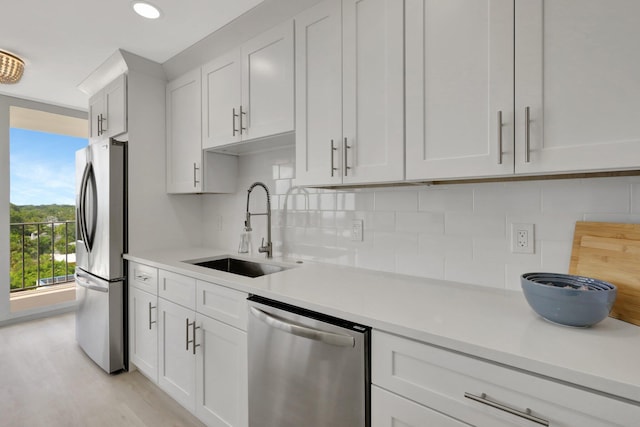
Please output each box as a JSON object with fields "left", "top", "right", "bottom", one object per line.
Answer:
{"left": 0, "top": 95, "right": 87, "bottom": 324}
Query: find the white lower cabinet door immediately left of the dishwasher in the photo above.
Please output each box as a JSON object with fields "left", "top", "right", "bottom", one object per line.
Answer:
{"left": 196, "top": 314, "right": 248, "bottom": 427}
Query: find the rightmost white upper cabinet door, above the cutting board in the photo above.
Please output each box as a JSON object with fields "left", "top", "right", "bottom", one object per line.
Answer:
{"left": 515, "top": 0, "right": 640, "bottom": 173}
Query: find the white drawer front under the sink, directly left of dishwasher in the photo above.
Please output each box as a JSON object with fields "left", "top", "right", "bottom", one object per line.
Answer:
{"left": 196, "top": 280, "right": 247, "bottom": 331}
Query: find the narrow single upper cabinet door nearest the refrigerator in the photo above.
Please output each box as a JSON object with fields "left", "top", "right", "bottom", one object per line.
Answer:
{"left": 166, "top": 69, "right": 202, "bottom": 193}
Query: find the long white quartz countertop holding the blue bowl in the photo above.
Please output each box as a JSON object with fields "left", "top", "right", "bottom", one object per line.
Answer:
{"left": 125, "top": 248, "right": 640, "bottom": 404}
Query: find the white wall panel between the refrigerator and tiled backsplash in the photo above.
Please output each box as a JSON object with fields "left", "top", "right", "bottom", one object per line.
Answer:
{"left": 127, "top": 70, "right": 202, "bottom": 253}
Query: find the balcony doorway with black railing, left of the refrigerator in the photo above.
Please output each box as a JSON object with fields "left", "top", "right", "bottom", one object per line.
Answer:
{"left": 9, "top": 106, "right": 88, "bottom": 312}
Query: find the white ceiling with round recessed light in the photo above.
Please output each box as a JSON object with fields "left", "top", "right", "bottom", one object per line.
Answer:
{"left": 0, "top": 0, "right": 263, "bottom": 110}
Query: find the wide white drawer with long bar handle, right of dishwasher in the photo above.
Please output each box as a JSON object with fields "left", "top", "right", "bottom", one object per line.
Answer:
{"left": 372, "top": 331, "right": 640, "bottom": 427}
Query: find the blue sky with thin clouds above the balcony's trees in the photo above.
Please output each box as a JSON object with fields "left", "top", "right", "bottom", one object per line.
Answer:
{"left": 9, "top": 128, "right": 88, "bottom": 206}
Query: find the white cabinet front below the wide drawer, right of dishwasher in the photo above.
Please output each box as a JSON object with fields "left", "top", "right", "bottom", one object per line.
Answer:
{"left": 371, "top": 386, "right": 469, "bottom": 427}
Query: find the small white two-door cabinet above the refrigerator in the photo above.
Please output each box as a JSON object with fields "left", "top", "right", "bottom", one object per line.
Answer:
{"left": 89, "top": 74, "right": 127, "bottom": 141}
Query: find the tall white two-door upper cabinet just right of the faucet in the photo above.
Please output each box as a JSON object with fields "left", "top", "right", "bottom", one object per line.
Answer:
{"left": 296, "top": 0, "right": 404, "bottom": 185}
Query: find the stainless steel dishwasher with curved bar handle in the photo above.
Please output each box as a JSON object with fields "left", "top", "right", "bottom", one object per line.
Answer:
{"left": 248, "top": 296, "right": 371, "bottom": 427}
